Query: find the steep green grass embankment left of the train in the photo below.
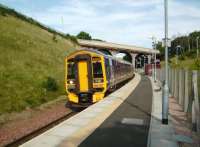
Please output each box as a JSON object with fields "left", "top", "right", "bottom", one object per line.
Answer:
{"left": 0, "top": 8, "right": 77, "bottom": 115}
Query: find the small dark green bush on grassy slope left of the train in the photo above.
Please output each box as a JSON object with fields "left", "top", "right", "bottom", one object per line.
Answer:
{"left": 43, "top": 77, "right": 58, "bottom": 91}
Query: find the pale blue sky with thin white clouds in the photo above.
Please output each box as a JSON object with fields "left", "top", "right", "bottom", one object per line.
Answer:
{"left": 0, "top": 0, "right": 200, "bottom": 48}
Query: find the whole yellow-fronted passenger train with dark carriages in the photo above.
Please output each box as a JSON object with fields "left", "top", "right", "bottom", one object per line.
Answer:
{"left": 65, "top": 49, "right": 134, "bottom": 107}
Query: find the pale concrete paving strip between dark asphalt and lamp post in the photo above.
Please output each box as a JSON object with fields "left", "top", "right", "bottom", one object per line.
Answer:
{"left": 148, "top": 78, "right": 178, "bottom": 147}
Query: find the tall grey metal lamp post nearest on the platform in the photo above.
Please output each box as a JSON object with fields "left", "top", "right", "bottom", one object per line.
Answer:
{"left": 162, "top": 0, "right": 169, "bottom": 124}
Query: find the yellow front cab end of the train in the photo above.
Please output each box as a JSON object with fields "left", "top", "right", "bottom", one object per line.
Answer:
{"left": 66, "top": 51, "right": 107, "bottom": 106}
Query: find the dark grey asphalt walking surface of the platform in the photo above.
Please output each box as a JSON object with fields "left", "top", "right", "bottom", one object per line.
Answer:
{"left": 79, "top": 77, "right": 152, "bottom": 147}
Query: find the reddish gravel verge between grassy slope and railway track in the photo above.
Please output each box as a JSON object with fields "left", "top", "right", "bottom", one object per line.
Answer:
{"left": 0, "top": 96, "right": 71, "bottom": 146}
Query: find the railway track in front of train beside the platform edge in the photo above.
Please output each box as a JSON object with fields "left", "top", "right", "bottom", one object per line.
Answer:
{"left": 5, "top": 111, "right": 78, "bottom": 147}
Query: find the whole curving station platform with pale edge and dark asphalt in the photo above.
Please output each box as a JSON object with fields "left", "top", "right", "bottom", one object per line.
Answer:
{"left": 21, "top": 74, "right": 180, "bottom": 147}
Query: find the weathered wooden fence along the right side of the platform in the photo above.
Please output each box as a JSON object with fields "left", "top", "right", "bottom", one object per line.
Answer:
{"left": 157, "top": 68, "right": 200, "bottom": 132}
